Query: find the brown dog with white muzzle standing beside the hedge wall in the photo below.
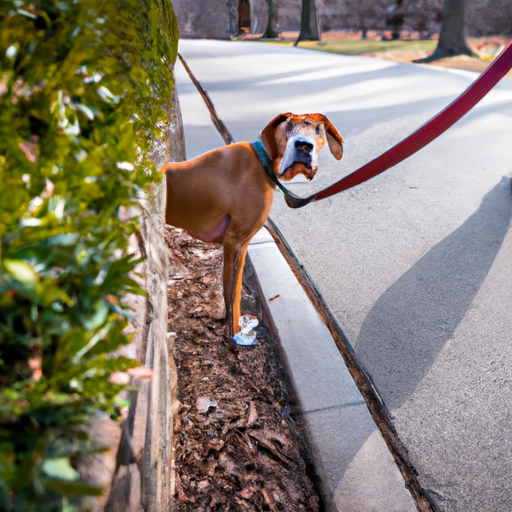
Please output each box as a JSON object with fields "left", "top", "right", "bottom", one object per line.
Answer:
{"left": 162, "top": 113, "right": 343, "bottom": 337}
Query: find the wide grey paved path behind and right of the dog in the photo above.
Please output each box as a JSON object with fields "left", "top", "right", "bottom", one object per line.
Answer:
{"left": 177, "top": 40, "right": 512, "bottom": 512}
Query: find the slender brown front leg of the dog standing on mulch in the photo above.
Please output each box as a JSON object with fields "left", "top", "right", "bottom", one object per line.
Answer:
{"left": 223, "top": 233, "right": 250, "bottom": 338}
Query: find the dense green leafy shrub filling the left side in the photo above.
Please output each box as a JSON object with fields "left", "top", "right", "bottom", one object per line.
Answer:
{"left": 0, "top": 0, "right": 178, "bottom": 512}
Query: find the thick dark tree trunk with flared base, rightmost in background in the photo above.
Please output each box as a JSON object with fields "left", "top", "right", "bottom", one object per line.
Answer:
{"left": 415, "top": 0, "right": 473, "bottom": 62}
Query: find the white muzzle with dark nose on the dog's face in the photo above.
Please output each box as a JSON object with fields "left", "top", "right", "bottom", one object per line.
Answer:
{"left": 277, "top": 134, "right": 318, "bottom": 180}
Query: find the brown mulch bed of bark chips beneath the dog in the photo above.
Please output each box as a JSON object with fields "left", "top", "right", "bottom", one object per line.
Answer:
{"left": 165, "top": 226, "right": 323, "bottom": 512}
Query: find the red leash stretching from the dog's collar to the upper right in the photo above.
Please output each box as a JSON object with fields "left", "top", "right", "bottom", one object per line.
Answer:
{"left": 285, "top": 41, "right": 512, "bottom": 208}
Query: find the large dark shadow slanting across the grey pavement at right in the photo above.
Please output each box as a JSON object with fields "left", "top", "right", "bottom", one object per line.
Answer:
{"left": 355, "top": 178, "right": 511, "bottom": 410}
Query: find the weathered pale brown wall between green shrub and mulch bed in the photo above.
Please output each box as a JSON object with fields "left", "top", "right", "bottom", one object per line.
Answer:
{"left": 78, "top": 84, "right": 186, "bottom": 512}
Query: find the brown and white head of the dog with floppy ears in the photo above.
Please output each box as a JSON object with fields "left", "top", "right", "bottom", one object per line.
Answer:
{"left": 261, "top": 112, "right": 343, "bottom": 181}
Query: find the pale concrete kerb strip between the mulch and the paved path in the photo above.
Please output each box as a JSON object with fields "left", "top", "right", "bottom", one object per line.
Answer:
{"left": 249, "top": 229, "right": 416, "bottom": 512}
